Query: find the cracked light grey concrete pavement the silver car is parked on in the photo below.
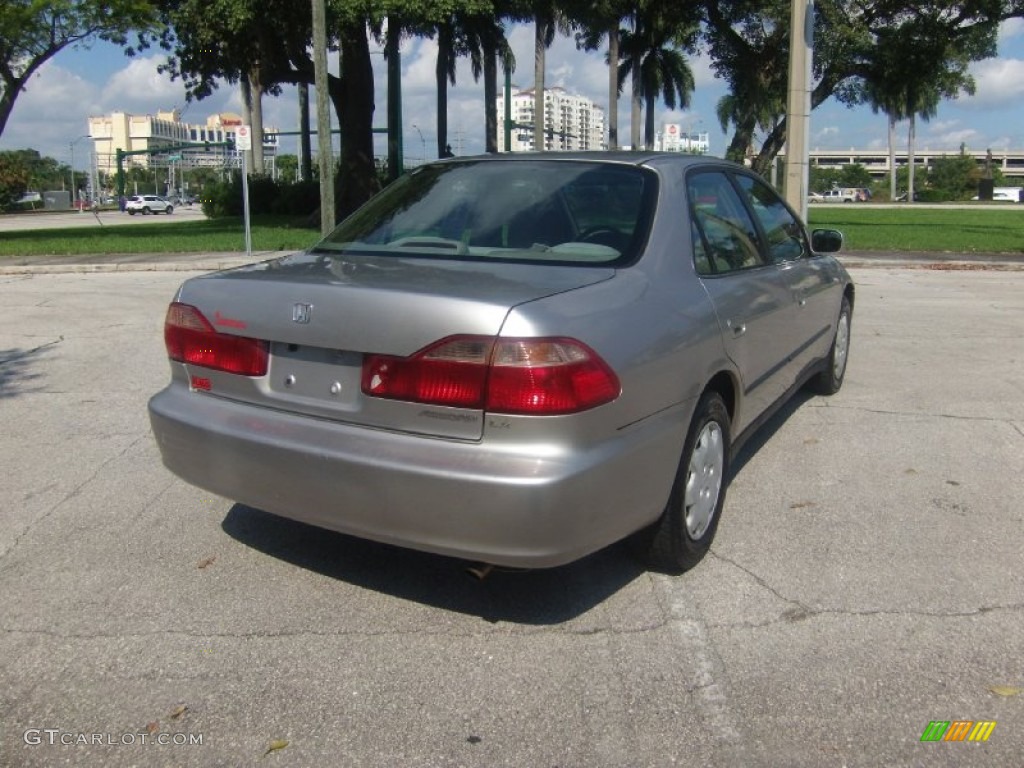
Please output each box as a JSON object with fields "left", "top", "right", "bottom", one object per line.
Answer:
{"left": 0, "top": 262, "right": 1024, "bottom": 768}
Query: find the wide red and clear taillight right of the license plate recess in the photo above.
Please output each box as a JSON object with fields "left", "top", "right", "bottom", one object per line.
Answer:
{"left": 362, "top": 336, "right": 620, "bottom": 416}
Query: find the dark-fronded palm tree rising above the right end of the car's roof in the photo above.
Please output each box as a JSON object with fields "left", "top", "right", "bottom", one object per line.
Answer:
{"left": 618, "top": 8, "right": 696, "bottom": 150}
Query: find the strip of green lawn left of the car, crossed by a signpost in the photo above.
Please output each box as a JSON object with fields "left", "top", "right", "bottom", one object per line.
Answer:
{"left": 0, "top": 217, "right": 319, "bottom": 258}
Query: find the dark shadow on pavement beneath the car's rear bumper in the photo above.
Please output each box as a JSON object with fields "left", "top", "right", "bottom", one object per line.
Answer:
{"left": 221, "top": 504, "right": 645, "bottom": 625}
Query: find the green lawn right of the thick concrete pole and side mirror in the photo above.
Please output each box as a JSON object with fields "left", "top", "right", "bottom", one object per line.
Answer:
{"left": 809, "top": 203, "right": 1024, "bottom": 253}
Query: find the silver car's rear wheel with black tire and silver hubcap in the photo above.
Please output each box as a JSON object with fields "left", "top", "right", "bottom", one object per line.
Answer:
{"left": 633, "top": 392, "right": 730, "bottom": 573}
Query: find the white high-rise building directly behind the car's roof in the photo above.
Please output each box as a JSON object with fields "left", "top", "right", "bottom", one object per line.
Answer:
{"left": 498, "top": 87, "right": 607, "bottom": 152}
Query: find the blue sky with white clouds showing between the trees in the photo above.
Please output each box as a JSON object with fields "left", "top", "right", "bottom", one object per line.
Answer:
{"left": 6, "top": 19, "right": 1024, "bottom": 168}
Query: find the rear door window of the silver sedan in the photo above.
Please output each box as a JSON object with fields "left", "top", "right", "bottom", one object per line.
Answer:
{"left": 687, "top": 171, "right": 765, "bottom": 274}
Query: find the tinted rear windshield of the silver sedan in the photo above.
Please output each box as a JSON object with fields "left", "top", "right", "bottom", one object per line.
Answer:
{"left": 313, "top": 160, "right": 657, "bottom": 265}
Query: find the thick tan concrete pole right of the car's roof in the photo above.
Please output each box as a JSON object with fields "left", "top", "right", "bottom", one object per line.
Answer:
{"left": 785, "top": 0, "right": 814, "bottom": 221}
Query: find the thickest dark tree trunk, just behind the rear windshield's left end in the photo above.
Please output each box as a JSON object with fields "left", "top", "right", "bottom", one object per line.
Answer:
{"left": 331, "top": 23, "right": 380, "bottom": 219}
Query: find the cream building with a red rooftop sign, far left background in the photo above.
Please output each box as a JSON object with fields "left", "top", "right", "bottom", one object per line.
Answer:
{"left": 89, "top": 110, "right": 278, "bottom": 173}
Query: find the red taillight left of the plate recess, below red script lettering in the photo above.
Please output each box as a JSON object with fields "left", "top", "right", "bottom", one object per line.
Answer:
{"left": 164, "top": 301, "right": 267, "bottom": 376}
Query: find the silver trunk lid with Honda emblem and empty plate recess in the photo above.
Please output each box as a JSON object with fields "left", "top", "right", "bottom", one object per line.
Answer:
{"left": 177, "top": 254, "right": 614, "bottom": 439}
